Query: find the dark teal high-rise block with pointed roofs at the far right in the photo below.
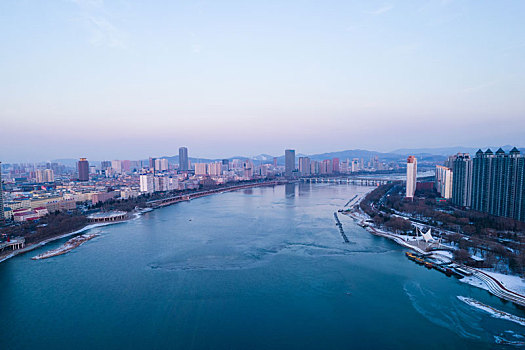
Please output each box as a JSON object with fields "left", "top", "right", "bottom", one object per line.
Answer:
{"left": 471, "top": 148, "right": 525, "bottom": 221}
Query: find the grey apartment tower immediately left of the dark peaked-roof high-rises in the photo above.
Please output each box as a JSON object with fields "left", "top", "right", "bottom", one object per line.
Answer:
{"left": 452, "top": 153, "right": 472, "bottom": 207}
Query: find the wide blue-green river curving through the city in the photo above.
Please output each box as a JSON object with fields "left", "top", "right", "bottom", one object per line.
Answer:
{"left": 0, "top": 184, "right": 525, "bottom": 350}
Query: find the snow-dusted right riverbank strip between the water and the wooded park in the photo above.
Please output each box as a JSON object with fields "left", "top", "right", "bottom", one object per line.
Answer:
{"left": 341, "top": 190, "right": 525, "bottom": 307}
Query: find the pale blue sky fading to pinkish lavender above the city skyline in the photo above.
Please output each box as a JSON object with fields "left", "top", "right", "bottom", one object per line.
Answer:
{"left": 0, "top": 0, "right": 525, "bottom": 162}
